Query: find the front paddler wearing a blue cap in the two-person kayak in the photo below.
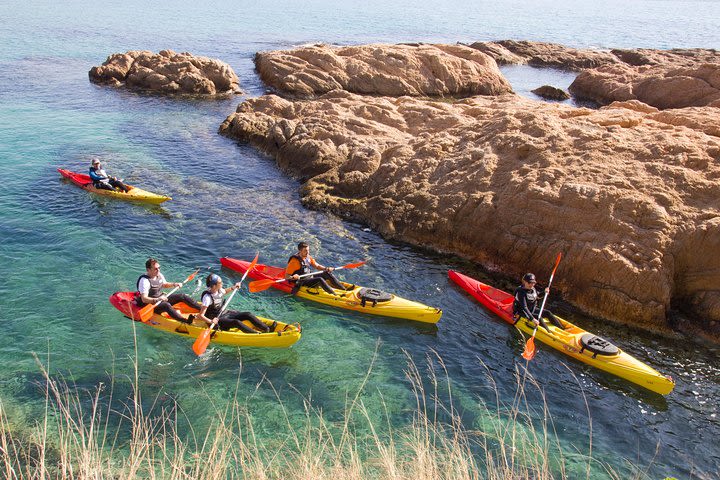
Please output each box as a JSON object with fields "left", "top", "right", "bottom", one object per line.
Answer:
{"left": 196, "top": 273, "right": 277, "bottom": 333}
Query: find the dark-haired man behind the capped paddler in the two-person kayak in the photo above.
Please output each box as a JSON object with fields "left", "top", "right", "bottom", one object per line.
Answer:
{"left": 135, "top": 258, "right": 200, "bottom": 324}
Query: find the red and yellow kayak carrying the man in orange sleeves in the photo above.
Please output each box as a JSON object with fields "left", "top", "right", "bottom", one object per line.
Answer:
{"left": 220, "top": 257, "right": 442, "bottom": 323}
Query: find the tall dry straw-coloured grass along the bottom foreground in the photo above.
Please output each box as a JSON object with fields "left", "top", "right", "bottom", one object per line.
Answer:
{"left": 0, "top": 338, "right": 645, "bottom": 480}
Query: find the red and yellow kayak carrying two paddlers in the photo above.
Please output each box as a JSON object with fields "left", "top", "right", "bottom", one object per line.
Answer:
{"left": 110, "top": 292, "right": 302, "bottom": 348}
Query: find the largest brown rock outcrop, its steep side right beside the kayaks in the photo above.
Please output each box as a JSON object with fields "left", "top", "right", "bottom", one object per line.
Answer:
{"left": 221, "top": 90, "right": 720, "bottom": 326}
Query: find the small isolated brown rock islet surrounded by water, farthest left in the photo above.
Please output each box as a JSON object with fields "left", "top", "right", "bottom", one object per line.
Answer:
{"left": 88, "top": 50, "right": 240, "bottom": 95}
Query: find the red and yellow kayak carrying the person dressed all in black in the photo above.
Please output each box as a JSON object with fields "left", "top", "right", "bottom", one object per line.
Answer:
{"left": 448, "top": 270, "right": 675, "bottom": 395}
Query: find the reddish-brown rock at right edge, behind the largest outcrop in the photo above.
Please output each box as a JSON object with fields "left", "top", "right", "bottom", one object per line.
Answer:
{"left": 569, "top": 61, "right": 720, "bottom": 109}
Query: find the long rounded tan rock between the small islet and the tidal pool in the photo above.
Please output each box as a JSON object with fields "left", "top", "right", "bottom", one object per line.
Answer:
{"left": 255, "top": 44, "right": 512, "bottom": 97}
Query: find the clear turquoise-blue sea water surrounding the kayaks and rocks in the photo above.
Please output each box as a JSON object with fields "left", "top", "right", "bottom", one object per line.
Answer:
{"left": 0, "top": 1, "right": 720, "bottom": 478}
